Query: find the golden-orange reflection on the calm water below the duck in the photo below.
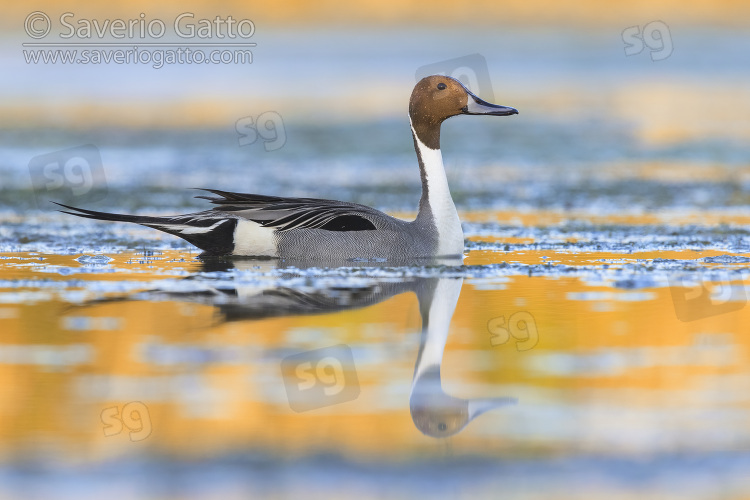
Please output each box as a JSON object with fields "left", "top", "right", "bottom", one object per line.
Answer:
{"left": 0, "top": 220, "right": 750, "bottom": 461}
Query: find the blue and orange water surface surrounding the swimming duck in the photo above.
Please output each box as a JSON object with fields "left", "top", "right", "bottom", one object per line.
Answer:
{"left": 0, "top": 25, "right": 750, "bottom": 498}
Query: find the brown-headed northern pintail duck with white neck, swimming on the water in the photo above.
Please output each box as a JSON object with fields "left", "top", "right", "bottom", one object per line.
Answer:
{"left": 61, "top": 75, "right": 518, "bottom": 260}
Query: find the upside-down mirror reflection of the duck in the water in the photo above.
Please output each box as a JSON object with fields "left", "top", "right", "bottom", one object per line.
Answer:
{"left": 89, "top": 259, "right": 516, "bottom": 438}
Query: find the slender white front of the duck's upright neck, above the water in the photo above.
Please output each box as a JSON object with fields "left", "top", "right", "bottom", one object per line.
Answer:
{"left": 409, "top": 119, "right": 464, "bottom": 256}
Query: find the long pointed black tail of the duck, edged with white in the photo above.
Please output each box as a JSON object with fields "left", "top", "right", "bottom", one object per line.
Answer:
{"left": 53, "top": 202, "right": 237, "bottom": 256}
